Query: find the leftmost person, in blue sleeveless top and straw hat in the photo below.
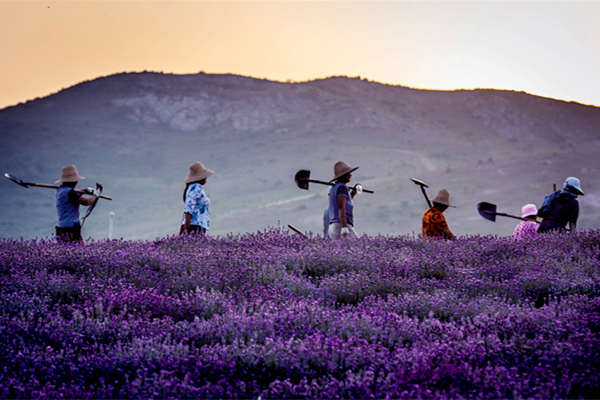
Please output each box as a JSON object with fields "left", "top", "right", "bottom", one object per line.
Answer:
{"left": 55, "top": 165, "right": 102, "bottom": 242}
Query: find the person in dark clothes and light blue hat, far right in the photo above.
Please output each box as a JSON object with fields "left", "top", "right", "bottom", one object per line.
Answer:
{"left": 538, "top": 177, "right": 583, "bottom": 232}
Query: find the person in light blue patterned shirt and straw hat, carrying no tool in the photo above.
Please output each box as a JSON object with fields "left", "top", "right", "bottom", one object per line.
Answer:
{"left": 179, "top": 161, "right": 215, "bottom": 235}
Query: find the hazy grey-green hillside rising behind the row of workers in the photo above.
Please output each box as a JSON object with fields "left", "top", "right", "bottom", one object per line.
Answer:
{"left": 0, "top": 72, "right": 600, "bottom": 238}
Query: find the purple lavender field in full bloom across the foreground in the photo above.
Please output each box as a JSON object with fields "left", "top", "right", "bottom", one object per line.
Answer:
{"left": 0, "top": 230, "right": 600, "bottom": 399}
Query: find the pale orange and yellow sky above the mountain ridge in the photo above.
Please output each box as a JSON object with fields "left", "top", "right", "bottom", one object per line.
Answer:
{"left": 0, "top": 0, "right": 600, "bottom": 108}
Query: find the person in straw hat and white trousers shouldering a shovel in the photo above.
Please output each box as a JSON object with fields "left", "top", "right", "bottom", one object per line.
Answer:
{"left": 328, "top": 161, "right": 358, "bottom": 239}
